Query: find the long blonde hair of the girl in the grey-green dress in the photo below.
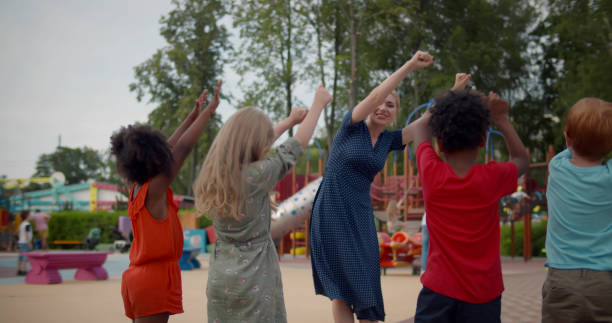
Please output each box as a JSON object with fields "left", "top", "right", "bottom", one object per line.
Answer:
{"left": 193, "top": 108, "right": 274, "bottom": 218}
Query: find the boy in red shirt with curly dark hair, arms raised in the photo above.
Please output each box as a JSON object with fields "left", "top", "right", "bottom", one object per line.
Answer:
{"left": 414, "top": 90, "right": 529, "bottom": 322}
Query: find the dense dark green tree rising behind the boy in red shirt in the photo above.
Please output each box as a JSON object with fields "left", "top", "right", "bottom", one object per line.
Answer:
{"left": 360, "top": 0, "right": 536, "bottom": 162}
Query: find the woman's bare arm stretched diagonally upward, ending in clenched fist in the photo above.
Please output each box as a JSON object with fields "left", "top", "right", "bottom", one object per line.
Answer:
{"left": 351, "top": 51, "right": 433, "bottom": 123}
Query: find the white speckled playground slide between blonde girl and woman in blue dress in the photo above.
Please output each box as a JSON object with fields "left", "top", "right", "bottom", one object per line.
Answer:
{"left": 270, "top": 177, "right": 322, "bottom": 240}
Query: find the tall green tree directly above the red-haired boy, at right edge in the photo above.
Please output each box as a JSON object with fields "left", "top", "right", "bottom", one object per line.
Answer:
{"left": 533, "top": 0, "right": 612, "bottom": 151}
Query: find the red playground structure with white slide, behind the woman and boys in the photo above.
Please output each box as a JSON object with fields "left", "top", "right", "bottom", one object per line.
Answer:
{"left": 272, "top": 100, "right": 555, "bottom": 270}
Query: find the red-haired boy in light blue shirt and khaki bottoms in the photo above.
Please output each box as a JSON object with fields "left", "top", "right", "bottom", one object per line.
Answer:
{"left": 542, "top": 98, "right": 612, "bottom": 323}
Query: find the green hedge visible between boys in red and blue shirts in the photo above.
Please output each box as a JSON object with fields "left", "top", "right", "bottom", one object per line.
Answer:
{"left": 500, "top": 221, "right": 547, "bottom": 257}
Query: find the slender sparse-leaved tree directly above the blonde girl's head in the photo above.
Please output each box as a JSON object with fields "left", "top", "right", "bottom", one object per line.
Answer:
{"left": 232, "top": 0, "right": 307, "bottom": 136}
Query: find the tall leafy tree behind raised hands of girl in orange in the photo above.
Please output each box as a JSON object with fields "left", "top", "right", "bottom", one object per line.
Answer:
{"left": 130, "top": 0, "right": 231, "bottom": 195}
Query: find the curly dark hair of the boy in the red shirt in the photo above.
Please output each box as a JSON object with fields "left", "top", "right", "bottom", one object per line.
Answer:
{"left": 429, "top": 90, "right": 490, "bottom": 153}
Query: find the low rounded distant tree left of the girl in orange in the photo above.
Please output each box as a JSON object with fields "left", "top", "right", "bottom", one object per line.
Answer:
{"left": 33, "top": 147, "right": 108, "bottom": 185}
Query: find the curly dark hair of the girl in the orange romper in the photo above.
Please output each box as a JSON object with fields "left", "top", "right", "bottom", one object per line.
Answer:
{"left": 111, "top": 125, "right": 172, "bottom": 185}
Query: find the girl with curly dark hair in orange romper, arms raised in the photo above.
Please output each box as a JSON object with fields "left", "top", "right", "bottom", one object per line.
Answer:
{"left": 111, "top": 80, "right": 221, "bottom": 322}
